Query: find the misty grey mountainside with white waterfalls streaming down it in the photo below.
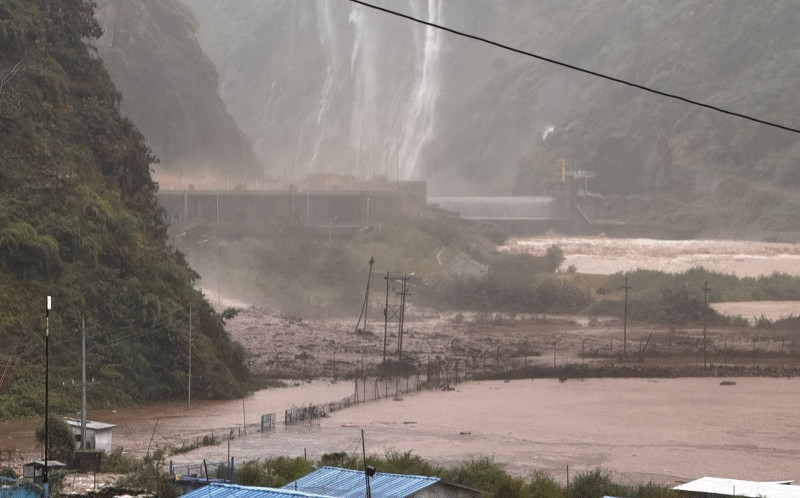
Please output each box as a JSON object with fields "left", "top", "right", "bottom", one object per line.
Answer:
{"left": 184, "top": 0, "right": 800, "bottom": 206}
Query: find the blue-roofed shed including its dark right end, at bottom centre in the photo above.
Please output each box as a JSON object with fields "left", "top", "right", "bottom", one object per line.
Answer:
{"left": 283, "top": 467, "right": 483, "bottom": 498}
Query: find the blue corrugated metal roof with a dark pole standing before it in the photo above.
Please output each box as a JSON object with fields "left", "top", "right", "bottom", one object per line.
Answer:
{"left": 283, "top": 467, "right": 439, "bottom": 498}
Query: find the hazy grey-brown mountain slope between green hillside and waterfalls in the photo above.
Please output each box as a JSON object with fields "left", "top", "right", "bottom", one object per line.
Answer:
{"left": 94, "top": 0, "right": 260, "bottom": 176}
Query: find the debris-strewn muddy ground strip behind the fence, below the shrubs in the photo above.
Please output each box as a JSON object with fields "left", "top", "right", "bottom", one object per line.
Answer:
{"left": 228, "top": 303, "right": 800, "bottom": 379}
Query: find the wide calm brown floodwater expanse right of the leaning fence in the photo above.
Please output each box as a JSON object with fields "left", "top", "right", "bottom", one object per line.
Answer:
{"left": 180, "top": 378, "right": 800, "bottom": 483}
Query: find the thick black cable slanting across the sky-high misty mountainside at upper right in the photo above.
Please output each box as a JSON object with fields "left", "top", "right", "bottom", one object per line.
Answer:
{"left": 349, "top": 0, "right": 800, "bottom": 134}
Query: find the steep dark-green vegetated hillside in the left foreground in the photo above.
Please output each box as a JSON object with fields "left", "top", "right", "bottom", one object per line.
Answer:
{"left": 0, "top": 0, "right": 246, "bottom": 419}
